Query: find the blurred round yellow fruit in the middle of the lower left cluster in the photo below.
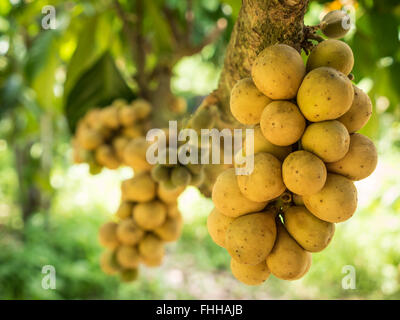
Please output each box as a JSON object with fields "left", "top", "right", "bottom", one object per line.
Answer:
{"left": 133, "top": 200, "right": 167, "bottom": 230}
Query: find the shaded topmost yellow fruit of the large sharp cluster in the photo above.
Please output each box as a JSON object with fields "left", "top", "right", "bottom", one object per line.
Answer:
{"left": 307, "top": 39, "right": 354, "bottom": 75}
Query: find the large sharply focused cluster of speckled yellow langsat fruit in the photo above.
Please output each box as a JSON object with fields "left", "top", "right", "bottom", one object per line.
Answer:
{"left": 208, "top": 33, "right": 377, "bottom": 285}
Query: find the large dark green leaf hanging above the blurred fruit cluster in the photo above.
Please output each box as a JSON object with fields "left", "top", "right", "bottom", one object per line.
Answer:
{"left": 65, "top": 52, "right": 134, "bottom": 132}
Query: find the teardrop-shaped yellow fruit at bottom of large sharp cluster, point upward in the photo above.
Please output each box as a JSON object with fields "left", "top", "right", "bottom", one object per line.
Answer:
{"left": 267, "top": 222, "right": 311, "bottom": 280}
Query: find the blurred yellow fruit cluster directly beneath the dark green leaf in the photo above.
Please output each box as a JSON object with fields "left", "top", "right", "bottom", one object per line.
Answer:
{"left": 73, "top": 99, "right": 151, "bottom": 174}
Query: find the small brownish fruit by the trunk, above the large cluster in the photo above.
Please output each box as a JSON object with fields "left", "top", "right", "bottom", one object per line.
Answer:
{"left": 321, "top": 10, "right": 350, "bottom": 39}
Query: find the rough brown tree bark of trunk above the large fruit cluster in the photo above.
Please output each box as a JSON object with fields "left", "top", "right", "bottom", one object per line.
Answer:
{"left": 213, "top": 0, "right": 309, "bottom": 123}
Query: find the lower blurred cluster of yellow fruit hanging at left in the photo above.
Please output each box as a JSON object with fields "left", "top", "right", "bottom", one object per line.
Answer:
{"left": 99, "top": 172, "right": 183, "bottom": 282}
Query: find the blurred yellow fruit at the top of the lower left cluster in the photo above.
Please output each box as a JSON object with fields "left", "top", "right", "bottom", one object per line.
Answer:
{"left": 121, "top": 172, "right": 156, "bottom": 202}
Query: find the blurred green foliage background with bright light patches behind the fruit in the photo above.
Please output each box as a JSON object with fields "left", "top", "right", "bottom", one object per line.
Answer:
{"left": 0, "top": 0, "right": 400, "bottom": 299}
